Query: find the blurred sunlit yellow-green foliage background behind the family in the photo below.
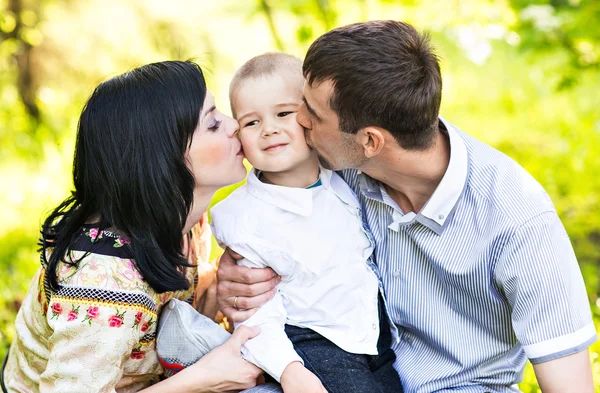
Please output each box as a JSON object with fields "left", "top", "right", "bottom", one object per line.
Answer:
{"left": 0, "top": 0, "right": 600, "bottom": 392}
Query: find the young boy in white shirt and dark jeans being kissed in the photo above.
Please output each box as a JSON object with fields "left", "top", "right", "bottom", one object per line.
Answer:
{"left": 211, "top": 53, "right": 402, "bottom": 393}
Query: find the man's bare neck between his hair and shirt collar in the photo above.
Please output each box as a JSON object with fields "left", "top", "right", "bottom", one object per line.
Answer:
{"left": 358, "top": 132, "right": 450, "bottom": 213}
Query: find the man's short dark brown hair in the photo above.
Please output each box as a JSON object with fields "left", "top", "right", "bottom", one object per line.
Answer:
{"left": 303, "top": 20, "right": 442, "bottom": 150}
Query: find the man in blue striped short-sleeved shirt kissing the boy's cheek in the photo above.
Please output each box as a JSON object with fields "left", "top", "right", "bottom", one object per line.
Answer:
{"left": 218, "top": 21, "right": 596, "bottom": 393}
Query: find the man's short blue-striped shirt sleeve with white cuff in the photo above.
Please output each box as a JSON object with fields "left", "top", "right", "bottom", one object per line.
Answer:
{"left": 496, "top": 211, "right": 596, "bottom": 364}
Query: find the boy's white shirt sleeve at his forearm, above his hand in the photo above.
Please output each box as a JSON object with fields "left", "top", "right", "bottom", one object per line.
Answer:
{"left": 235, "top": 292, "right": 304, "bottom": 382}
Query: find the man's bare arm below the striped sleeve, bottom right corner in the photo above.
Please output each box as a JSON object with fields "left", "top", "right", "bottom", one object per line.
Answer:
{"left": 533, "top": 349, "right": 594, "bottom": 393}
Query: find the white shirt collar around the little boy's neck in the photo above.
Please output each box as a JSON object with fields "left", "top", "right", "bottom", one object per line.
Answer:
{"left": 246, "top": 168, "right": 358, "bottom": 217}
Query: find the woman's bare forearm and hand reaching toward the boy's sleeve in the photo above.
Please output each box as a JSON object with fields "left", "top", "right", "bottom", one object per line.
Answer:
{"left": 140, "top": 326, "right": 262, "bottom": 393}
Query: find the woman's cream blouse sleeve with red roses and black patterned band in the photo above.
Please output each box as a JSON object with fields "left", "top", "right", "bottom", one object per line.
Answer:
{"left": 40, "top": 278, "right": 156, "bottom": 393}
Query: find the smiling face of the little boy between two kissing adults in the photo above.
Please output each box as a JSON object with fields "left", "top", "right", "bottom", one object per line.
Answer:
{"left": 232, "top": 74, "right": 315, "bottom": 172}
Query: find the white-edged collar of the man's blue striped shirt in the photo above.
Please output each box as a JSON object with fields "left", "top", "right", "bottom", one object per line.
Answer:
{"left": 359, "top": 117, "right": 469, "bottom": 235}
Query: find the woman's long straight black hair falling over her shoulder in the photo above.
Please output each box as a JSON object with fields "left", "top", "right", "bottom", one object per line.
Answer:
{"left": 40, "top": 61, "right": 206, "bottom": 293}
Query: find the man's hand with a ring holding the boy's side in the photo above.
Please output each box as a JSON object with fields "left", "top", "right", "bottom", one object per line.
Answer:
{"left": 217, "top": 249, "right": 281, "bottom": 322}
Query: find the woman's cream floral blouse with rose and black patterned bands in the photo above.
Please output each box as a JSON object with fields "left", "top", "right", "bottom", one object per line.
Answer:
{"left": 4, "top": 217, "right": 210, "bottom": 393}
